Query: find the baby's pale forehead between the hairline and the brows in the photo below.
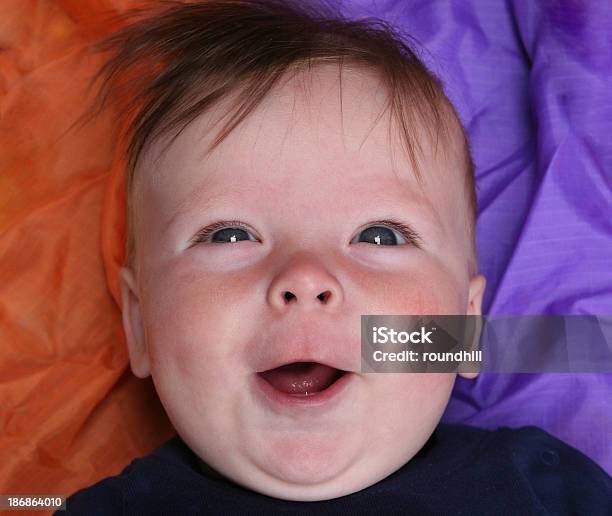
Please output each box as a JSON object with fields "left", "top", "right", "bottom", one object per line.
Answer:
{"left": 136, "top": 64, "right": 463, "bottom": 238}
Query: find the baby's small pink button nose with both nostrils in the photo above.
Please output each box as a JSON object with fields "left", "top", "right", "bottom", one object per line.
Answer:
{"left": 268, "top": 255, "right": 343, "bottom": 310}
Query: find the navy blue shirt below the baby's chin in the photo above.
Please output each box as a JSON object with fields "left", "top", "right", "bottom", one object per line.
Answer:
{"left": 66, "top": 424, "right": 612, "bottom": 516}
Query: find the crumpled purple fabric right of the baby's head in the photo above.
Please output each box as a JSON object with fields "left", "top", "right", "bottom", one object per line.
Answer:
{"left": 341, "top": 0, "right": 612, "bottom": 473}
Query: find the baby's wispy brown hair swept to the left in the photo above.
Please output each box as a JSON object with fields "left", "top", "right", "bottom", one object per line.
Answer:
{"left": 82, "top": 0, "right": 476, "bottom": 272}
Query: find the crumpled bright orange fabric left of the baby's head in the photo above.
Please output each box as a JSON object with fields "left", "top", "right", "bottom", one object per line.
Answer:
{"left": 0, "top": 0, "right": 174, "bottom": 500}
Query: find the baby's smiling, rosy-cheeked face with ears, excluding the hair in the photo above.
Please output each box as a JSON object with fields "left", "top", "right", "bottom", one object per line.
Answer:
{"left": 122, "top": 65, "right": 484, "bottom": 500}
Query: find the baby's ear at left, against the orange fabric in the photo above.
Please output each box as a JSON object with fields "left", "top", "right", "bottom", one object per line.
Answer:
{"left": 119, "top": 267, "right": 151, "bottom": 378}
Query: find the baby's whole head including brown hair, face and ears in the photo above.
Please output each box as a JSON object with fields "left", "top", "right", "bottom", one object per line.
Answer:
{"left": 94, "top": 1, "right": 485, "bottom": 500}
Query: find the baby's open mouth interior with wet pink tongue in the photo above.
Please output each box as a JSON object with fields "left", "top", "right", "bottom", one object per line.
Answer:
{"left": 259, "top": 362, "right": 342, "bottom": 396}
